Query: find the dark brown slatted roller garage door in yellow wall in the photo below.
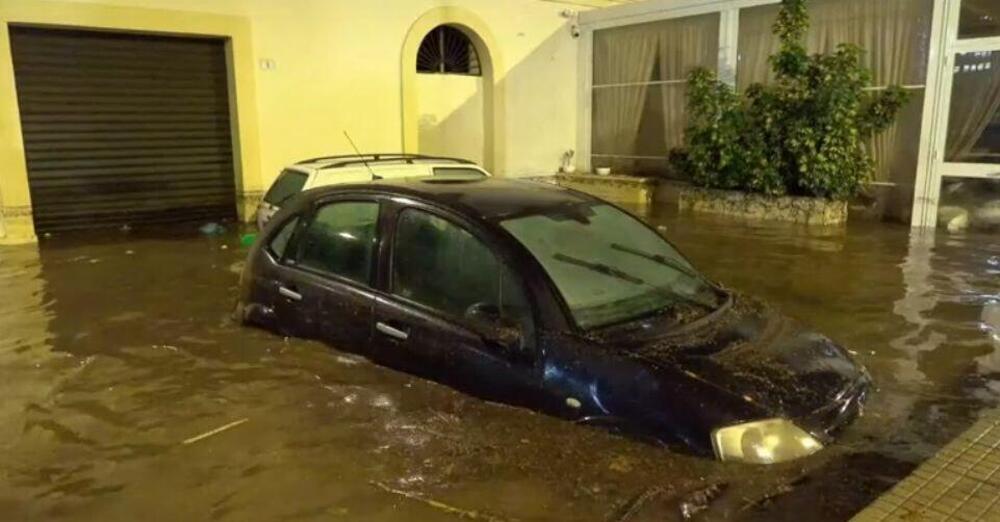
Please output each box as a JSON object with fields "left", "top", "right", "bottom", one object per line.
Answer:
{"left": 9, "top": 27, "right": 236, "bottom": 232}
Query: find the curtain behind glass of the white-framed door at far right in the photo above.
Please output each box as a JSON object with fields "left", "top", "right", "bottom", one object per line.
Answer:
{"left": 945, "top": 51, "right": 1000, "bottom": 162}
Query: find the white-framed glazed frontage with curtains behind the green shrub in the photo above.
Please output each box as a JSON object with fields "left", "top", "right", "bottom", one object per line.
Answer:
{"left": 577, "top": 0, "right": 1000, "bottom": 228}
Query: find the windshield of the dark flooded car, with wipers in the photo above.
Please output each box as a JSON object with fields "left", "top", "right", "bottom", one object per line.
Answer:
{"left": 501, "top": 203, "right": 721, "bottom": 329}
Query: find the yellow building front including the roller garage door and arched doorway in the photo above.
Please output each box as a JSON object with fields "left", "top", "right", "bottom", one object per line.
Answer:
{"left": 0, "top": 0, "right": 592, "bottom": 243}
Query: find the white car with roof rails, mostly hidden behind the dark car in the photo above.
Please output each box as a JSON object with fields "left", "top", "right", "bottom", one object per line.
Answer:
{"left": 257, "top": 153, "right": 490, "bottom": 229}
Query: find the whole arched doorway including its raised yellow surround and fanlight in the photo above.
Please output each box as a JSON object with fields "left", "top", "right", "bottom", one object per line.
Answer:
{"left": 401, "top": 7, "right": 505, "bottom": 174}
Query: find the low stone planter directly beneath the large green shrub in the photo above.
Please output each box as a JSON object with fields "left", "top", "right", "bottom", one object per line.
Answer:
{"left": 677, "top": 187, "right": 847, "bottom": 225}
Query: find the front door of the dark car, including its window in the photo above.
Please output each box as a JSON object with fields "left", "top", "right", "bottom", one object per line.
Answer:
{"left": 373, "top": 203, "right": 540, "bottom": 404}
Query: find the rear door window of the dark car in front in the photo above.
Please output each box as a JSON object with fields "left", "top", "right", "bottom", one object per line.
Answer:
{"left": 297, "top": 201, "right": 379, "bottom": 284}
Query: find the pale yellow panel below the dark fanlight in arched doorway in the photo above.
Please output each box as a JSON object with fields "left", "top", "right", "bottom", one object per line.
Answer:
{"left": 417, "top": 74, "right": 485, "bottom": 164}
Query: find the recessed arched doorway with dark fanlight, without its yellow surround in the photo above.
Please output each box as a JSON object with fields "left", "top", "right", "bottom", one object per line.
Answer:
{"left": 415, "top": 25, "right": 485, "bottom": 164}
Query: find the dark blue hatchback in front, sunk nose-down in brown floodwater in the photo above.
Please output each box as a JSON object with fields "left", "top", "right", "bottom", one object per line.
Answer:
{"left": 237, "top": 178, "right": 871, "bottom": 463}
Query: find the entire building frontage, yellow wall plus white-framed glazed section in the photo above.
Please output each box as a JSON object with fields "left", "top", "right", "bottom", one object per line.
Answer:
{"left": 0, "top": 0, "right": 1000, "bottom": 243}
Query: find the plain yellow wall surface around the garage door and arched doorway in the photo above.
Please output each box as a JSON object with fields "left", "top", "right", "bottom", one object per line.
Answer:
{"left": 0, "top": 0, "right": 577, "bottom": 242}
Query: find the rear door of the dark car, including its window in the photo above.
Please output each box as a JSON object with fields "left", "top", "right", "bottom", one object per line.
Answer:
{"left": 275, "top": 198, "right": 379, "bottom": 353}
